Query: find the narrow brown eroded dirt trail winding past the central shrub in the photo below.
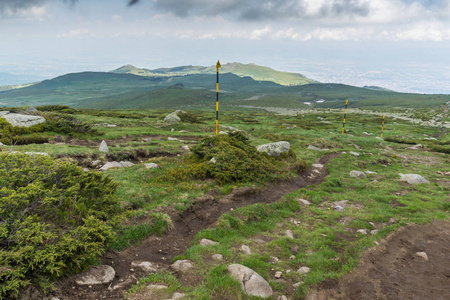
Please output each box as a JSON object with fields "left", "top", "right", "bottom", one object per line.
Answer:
{"left": 52, "top": 153, "right": 339, "bottom": 300}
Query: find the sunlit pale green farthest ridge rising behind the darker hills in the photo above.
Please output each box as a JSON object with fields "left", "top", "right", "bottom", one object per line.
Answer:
{"left": 111, "top": 62, "right": 316, "bottom": 85}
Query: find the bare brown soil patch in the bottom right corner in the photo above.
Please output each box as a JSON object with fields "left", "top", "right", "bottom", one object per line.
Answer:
{"left": 306, "top": 221, "right": 450, "bottom": 300}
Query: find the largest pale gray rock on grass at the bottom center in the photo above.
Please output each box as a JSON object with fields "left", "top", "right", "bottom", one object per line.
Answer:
{"left": 228, "top": 264, "right": 273, "bottom": 298}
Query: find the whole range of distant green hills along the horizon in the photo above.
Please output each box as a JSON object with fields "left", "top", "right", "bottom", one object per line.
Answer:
{"left": 0, "top": 63, "right": 450, "bottom": 109}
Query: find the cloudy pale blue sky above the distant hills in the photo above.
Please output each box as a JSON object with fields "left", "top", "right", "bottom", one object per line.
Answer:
{"left": 0, "top": 0, "right": 450, "bottom": 94}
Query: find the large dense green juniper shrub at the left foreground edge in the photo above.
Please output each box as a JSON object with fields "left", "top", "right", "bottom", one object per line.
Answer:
{"left": 0, "top": 152, "right": 119, "bottom": 299}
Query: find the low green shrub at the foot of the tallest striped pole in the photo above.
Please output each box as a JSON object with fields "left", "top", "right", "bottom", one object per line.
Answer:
{"left": 162, "top": 131, "right": 296, "bottom": 184}
